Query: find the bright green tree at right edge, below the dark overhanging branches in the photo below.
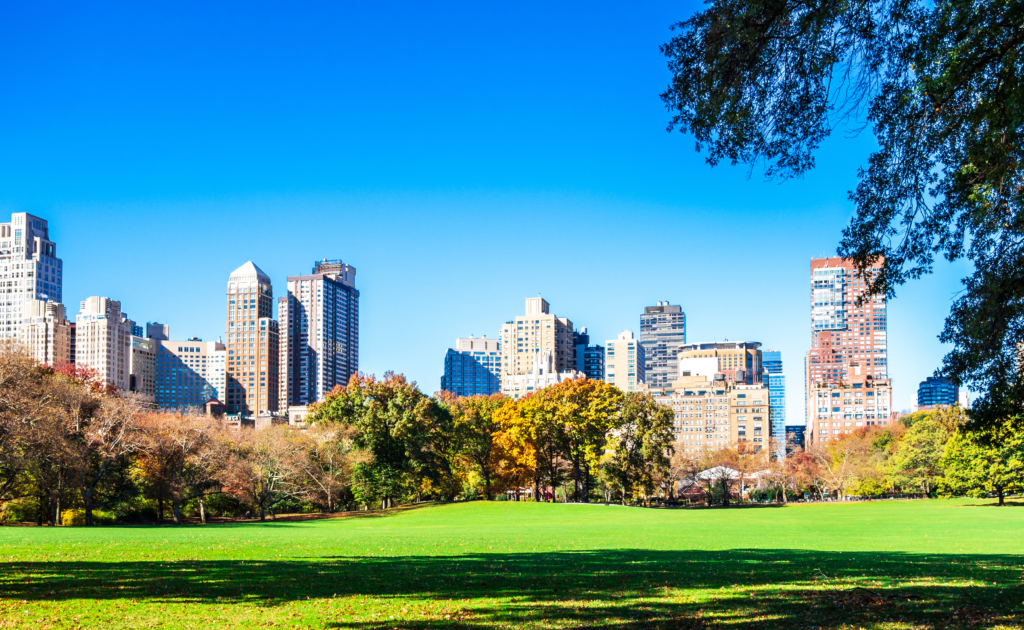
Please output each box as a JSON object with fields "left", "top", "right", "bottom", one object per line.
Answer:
{"left": 942, "top": 420, "right": 1024, "bottom": 505}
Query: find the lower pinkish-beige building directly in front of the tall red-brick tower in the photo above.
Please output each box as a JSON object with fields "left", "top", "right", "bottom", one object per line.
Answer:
{"left": 806, "top": 361, "right": 892, "bottom": 446}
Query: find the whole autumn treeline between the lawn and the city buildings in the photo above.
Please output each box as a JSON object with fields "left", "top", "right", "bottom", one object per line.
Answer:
{"left": 0, "top": 346, "right": 1024, "bottom": 526}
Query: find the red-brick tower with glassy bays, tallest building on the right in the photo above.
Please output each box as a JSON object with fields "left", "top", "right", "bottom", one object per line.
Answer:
{"left": 806, "top": 258, "right": 889, "bottom": 384}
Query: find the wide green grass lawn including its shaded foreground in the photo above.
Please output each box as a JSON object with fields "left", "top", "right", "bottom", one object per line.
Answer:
{"left": 0, "top": 501, "right": 1024, "bottom": 629}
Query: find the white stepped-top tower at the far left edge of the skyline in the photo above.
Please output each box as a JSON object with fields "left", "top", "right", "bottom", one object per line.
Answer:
{"left": 0, "top": 212, "right": 63, "bottom": 340}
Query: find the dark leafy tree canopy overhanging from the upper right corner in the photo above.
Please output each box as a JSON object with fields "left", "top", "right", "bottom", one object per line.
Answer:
{"left": 662, "top": 0, "right": 1024, "bottom": 434}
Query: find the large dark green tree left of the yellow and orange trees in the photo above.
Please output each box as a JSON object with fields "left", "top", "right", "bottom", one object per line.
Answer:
{"left": 306, "top": 372, "right": 434, "bottom": 508}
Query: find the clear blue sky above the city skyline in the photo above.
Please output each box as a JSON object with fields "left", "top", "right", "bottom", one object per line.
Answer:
{"left": 0, "top": 2, "right": 966, "bottom": 423}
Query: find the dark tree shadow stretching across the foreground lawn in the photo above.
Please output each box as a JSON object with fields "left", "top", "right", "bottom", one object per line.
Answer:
{"left": 0, "top": 549, "right": 1024, "bottom": 629}
